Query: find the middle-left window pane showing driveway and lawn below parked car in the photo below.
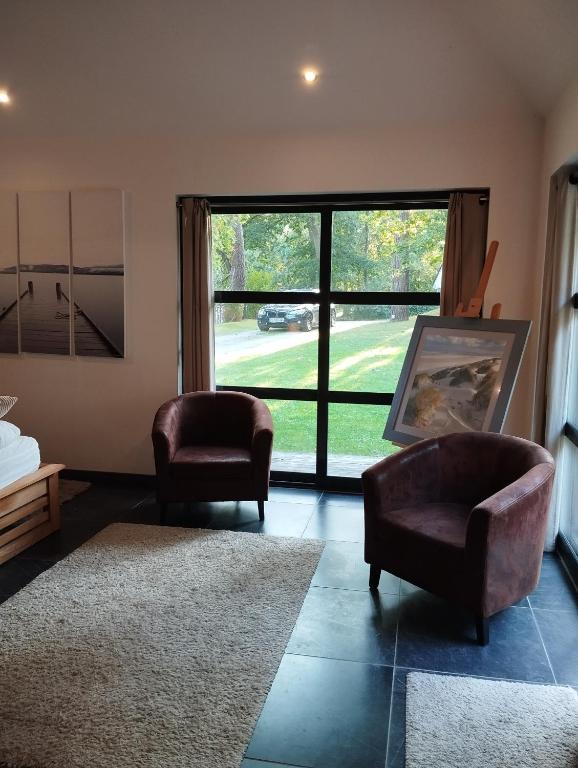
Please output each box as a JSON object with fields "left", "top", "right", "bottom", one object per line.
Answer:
{"left": 215, "top": 304, "right": 319, "bottom": 389}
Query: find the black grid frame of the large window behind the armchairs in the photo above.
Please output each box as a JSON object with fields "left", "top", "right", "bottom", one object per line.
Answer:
{"left": 177, "top": 188, "right": 490, "bottom": 492}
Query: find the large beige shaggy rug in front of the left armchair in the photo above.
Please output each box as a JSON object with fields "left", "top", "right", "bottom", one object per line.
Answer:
{"left": 0, "top": 524, "right": 323, "bottom": 768}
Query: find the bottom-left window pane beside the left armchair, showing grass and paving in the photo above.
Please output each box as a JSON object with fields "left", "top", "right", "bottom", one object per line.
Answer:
{"left": 265, "top": 400, "right": 317, "bottom": 473}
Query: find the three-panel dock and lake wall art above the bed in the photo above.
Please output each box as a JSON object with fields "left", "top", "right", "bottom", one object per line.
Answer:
{"left": 0, "top": 190, "right": 125, "bottom": 357}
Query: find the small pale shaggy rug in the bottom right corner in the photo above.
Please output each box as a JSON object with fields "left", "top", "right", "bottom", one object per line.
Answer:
{"left": 406, "top": 672, "right": 578, "bottom": 768}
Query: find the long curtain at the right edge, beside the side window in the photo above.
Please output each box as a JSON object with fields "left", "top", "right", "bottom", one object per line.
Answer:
{"left": 533, "top": 167, "right": 578, "bottom": 549}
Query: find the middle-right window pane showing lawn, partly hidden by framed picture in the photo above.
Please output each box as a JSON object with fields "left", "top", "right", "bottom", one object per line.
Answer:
{"left": 329, "top": 304, "right": 439, "bottom": 393}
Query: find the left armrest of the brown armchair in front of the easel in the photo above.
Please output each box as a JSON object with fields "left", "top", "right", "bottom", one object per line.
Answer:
{"left": 361, "top": 438, "right": 440, "bottom": 517}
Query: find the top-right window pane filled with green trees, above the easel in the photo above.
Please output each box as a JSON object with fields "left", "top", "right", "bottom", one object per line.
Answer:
{"left": 331, "top": 209, "right": 447, "bottom": 291}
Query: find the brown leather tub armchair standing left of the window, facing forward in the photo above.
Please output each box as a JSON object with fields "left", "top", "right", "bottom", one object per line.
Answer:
{"left": 152, "top": 392, "right": 273, "bottom": 520}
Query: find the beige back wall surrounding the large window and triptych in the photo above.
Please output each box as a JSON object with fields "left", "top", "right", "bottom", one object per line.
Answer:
{"left": 0, "top": 115, "right": 542, "bottom": 472}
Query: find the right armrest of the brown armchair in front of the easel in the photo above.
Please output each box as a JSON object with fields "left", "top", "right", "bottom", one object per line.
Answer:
{"left": 465, "top": 464, "right": 554, "bottom": 616}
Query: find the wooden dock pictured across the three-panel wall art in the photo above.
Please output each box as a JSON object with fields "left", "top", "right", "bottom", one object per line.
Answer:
{"left": 0, "top": 280, "right": 122, "bottom": 357}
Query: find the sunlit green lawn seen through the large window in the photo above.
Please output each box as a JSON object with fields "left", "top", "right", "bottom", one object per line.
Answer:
{"left": 217, "top": 317, "right": 415, "bottom": 457}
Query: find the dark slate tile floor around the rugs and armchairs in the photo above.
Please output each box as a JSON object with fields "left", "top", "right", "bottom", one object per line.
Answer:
{"left": 0, "top": 484, "right": 578, "bottom": 768}
